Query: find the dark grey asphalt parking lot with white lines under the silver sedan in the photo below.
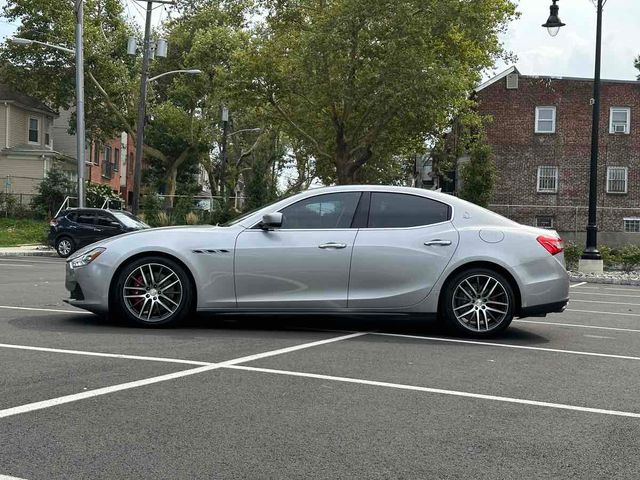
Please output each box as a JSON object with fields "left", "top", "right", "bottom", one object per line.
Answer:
{"left": 0, "top": 257, "right": 640, "bottom": 480}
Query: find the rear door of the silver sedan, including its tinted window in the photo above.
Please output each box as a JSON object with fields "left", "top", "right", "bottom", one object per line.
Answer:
{"left": 348, "top": 192, "right": 458, "bottom": 308}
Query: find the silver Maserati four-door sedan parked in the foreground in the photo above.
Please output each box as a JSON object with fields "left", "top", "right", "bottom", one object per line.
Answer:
{"left": 66, "top": 185, "right": 569, "bottom": 336}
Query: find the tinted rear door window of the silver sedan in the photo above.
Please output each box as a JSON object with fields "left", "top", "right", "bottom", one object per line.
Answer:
{"left": 369, "top": 192, "right": 450, "bottom": 228}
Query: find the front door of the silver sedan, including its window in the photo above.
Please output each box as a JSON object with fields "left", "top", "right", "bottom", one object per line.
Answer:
{"left": 234, "top": 192, "right": 361, "bottom": 309}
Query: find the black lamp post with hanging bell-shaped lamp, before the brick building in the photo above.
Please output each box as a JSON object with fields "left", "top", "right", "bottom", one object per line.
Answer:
{"left": 542, "top": 0, "right": 604, "bottom": 273}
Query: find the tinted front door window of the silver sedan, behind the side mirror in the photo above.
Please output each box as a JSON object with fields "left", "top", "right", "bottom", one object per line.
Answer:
{"left": 281, "top": 192, "right": 360, "bottom": 229}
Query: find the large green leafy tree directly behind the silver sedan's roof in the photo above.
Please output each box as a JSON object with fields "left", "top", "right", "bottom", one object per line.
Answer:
{"left": 232, "top": 0, "right": 516, "bottom": 184}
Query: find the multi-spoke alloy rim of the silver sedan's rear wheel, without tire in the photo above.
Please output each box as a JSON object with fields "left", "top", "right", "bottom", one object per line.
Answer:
{"left": 452, "top": 275, "right": 509, "bottom": 332}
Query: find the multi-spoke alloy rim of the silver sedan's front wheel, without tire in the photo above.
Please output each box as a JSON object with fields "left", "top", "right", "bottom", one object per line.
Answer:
{"left": 122, "top": 263, "right": 183, "bottom": 323}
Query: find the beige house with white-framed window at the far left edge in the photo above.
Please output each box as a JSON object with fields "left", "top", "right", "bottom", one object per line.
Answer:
{"left": 0, "top": 84, "right": 75, "bottom": 204}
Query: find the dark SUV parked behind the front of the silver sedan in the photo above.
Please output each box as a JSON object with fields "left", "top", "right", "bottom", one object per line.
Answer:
{"left": 48, "top": 208, "right": 149, "bottom": 258}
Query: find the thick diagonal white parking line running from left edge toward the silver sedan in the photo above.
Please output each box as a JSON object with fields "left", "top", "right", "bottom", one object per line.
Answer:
{"left": 0, "top": 332, "right": 367, "bottom": 418}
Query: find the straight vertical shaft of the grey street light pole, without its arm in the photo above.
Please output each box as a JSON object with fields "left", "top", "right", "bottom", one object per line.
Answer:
{"left": 75, "top": 0, "right": 86, "bottom": 208}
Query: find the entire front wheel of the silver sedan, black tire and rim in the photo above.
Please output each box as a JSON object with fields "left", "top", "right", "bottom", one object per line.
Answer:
{"left": 111, "top": 256, "right": 195, "bottom": 327}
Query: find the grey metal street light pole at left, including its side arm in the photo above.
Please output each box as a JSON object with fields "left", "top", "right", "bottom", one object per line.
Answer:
{"left": 9, "top": 36, "right": 85, "bottom": 208}
